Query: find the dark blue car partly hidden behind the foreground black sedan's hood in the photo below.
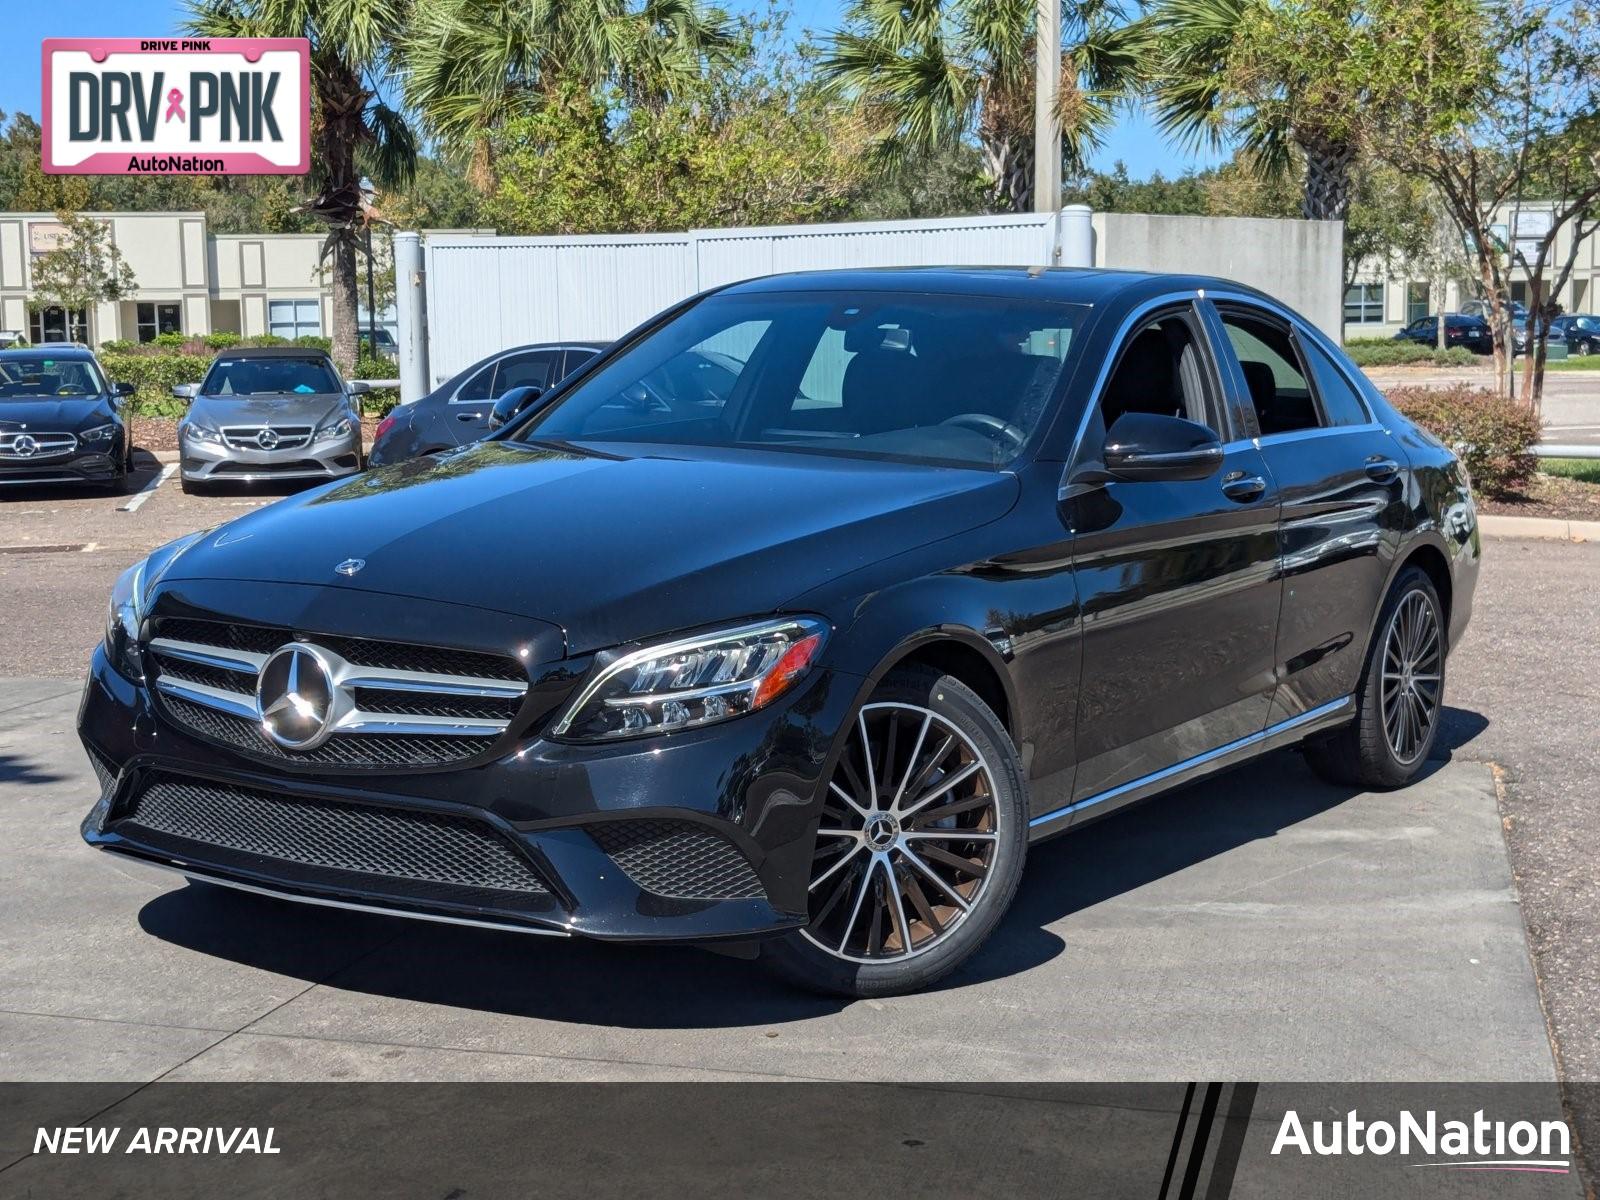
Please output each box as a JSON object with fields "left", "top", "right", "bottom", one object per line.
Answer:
{"left": 370, "top": 342, "right": 605, "bottom": 466}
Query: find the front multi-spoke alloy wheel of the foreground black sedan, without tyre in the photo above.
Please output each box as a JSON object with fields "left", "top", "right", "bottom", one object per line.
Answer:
{"left": 803, "top": 702, "right": 1000, "bottom": 963}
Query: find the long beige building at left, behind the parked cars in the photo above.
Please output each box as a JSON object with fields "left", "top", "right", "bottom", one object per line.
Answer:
{"left": 0, "top": 213, "right": 347, "bottom": 346}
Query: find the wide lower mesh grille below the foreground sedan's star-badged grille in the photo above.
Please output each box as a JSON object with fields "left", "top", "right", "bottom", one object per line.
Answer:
{"left": 117, "top": 774, "right": 549, "bottom": 896}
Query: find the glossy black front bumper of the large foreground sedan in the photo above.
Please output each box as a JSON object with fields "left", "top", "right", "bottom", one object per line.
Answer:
{"left": 78, "top": 650, "right": 861, "bottom": 942}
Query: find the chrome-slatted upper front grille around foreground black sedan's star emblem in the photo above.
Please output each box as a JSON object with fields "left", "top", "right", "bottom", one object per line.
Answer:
{"left": 147, "top": 619, "right": 528, "bottom": 770}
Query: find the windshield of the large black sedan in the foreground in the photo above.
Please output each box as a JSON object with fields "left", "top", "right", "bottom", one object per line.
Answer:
{"left": 515, "top": 291, "right": 1088, "bottom": 467}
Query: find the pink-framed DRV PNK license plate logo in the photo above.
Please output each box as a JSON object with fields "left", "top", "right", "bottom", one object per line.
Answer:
{"left": 43, "top": 37, "right": 310, "bottom": 174}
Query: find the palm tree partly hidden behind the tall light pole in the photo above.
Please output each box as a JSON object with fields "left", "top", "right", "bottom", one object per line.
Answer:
{"left": 821, "top": 0, "right": 1149, "bottom": 211}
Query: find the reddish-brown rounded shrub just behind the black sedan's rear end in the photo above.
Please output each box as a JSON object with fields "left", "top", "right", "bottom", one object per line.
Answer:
{"left": 1389, "top": 384, "right": 1542, "bottom": 496}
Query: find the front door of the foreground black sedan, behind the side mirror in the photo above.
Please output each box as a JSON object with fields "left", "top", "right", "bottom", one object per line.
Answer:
{"left": 1064, "top": 304, "right": 1280, "bottom": 803}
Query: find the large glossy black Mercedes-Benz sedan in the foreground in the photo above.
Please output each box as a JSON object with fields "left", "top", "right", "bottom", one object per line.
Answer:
{"left": 80, "top": 269, "right": 1480, "bottom": 995}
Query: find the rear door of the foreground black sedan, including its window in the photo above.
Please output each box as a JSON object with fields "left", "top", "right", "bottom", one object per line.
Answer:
{"left": 1206, "top": 299, "right": 1406, "bottom": 725}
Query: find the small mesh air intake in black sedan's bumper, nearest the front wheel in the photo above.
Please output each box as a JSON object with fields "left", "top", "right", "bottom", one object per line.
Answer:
{"left": 586, "top": 821, "right": 766, "bottom": 899}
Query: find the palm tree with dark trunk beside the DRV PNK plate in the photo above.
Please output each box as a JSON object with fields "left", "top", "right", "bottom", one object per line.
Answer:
{"left": 187, "top": 0, "right": 416, "bottom": 370}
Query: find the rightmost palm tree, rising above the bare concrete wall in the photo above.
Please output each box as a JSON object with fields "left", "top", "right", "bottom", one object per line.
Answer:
{"left": 1150, "top": 0, "right": 1373, "bottom": 221}
